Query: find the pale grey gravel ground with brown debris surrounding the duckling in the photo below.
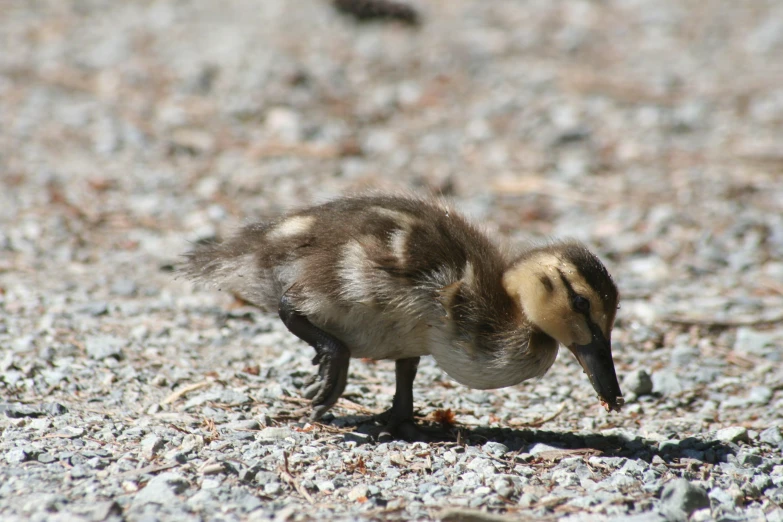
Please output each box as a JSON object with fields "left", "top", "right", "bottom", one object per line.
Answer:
{"left": 0, "top": 0, "right": 783, "bottom": 522}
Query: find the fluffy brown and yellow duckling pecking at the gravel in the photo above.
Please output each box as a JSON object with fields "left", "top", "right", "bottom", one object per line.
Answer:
{"left": 183, "top": 196, "right": 623, "bottom": 438}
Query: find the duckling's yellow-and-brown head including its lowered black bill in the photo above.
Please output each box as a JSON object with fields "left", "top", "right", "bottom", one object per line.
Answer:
{"left": 503, "top": 241, "right": 623, "bottom": 411}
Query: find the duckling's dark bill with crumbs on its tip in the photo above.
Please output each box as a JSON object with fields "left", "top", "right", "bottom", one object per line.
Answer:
{"left": 568, "top": 332, "right": 625, "bottom": 411}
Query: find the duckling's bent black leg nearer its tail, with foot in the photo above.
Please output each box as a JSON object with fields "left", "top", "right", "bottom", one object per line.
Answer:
{"left": 278, "top": 295, "right": 348, "bottom": 420}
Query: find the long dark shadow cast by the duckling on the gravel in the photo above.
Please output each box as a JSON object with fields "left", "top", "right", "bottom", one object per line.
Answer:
{"left": 341, "top": 416, "right": 739, "bottom": 466}
